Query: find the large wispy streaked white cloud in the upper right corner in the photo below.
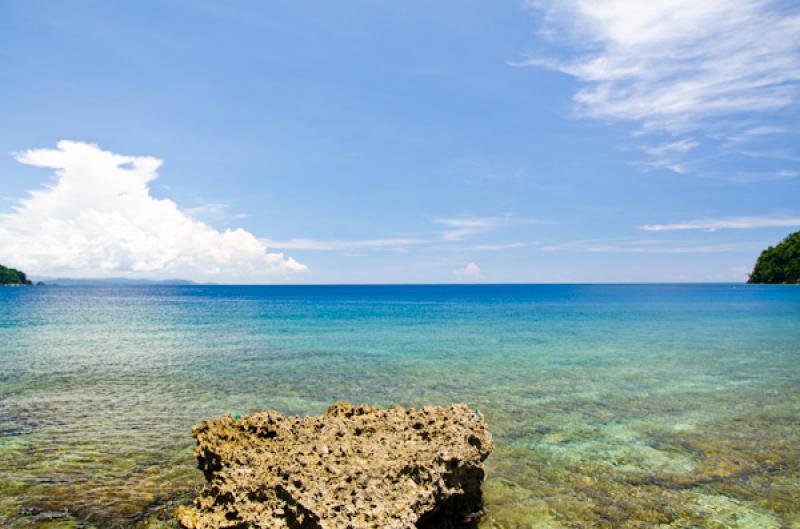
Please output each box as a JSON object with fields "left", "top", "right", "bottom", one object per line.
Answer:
{"left": 523, "top": 0, "right": 800, "bottom": 132}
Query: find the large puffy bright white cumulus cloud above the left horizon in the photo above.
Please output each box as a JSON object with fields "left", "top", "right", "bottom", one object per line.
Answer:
{"left": 0, "top": 141, "right": 306, "bottom": 281}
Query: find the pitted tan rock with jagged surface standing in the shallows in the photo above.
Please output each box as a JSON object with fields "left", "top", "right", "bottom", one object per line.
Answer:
{"left": 177, "top": 402, "right": 492, "bottom": 529}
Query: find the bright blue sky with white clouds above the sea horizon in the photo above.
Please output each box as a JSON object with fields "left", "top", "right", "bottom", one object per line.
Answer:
{"left": 0, "top": 0, "right": 800, "bottom": 284}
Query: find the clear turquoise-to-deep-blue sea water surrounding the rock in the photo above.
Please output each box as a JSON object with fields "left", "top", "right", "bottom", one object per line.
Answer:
{"left": 0, "top": 284, "right": 800, "bottom": 529}
